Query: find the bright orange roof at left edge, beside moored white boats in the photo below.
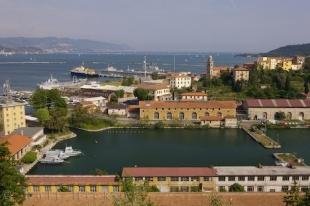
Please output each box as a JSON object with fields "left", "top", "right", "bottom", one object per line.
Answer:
{"left": 0, "top": 134, "right": 32, "bottom": 155}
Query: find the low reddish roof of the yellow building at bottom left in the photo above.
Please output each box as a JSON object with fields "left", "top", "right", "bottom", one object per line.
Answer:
{"left": 26, "top": 175, "right": 116, "bottom": 185}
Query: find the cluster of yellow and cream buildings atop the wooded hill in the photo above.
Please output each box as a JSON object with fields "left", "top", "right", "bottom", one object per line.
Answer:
{"left": 257, "top": 56, "right": 305, "bottom": 71}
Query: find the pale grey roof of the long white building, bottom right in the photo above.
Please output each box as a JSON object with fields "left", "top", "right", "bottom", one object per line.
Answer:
{"left": 214, "top": 166, "right": 310, "bottom": 176}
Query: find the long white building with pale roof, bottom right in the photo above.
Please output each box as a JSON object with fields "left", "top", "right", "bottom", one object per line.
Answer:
{"left": 214, "top": 166, "right": 310, "bottom": 192}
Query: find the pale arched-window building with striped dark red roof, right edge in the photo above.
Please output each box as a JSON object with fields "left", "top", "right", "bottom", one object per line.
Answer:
{"left": 242, "top": 99, "right": 310, "bottom": 121}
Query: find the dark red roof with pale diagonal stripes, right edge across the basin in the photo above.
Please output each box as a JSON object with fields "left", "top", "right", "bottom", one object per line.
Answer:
{"left": 243, "top": 99, "right": 310, "bottom": 108}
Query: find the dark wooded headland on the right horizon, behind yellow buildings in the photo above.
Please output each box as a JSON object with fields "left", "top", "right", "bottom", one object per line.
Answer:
{"left": 237, "top": 43, "right": 310, "bottom": 57}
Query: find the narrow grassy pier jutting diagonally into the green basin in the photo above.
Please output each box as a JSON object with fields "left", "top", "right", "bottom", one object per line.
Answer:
{"left": 241, "top": 126, "right": 281, "bottom": 149}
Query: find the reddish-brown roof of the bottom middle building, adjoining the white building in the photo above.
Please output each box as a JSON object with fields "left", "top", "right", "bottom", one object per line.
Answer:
{"left": 122, "top": 167, "right": 216, "bottom": 177}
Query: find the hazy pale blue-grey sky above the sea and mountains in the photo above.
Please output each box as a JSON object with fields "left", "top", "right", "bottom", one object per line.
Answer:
{"left": 0, "top": 0, "right": 310, "bottom": 52}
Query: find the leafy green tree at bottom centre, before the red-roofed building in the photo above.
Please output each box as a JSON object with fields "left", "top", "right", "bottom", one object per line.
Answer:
{"left": 114, "top": 178, "right": 154, "bottom": 206}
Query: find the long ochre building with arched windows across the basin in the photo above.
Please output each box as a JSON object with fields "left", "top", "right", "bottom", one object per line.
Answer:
{"left": 139, "top": 101, "right": 237, "bottom": 122}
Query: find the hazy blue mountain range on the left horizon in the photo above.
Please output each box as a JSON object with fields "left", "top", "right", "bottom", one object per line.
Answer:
{"left": 0, "top": 37, "right": 132, "bottom": 54}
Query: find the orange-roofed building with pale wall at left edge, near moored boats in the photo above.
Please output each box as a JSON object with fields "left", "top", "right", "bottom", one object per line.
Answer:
{"left": 0, "top": 135, "right": 32, "bottom": 160}
